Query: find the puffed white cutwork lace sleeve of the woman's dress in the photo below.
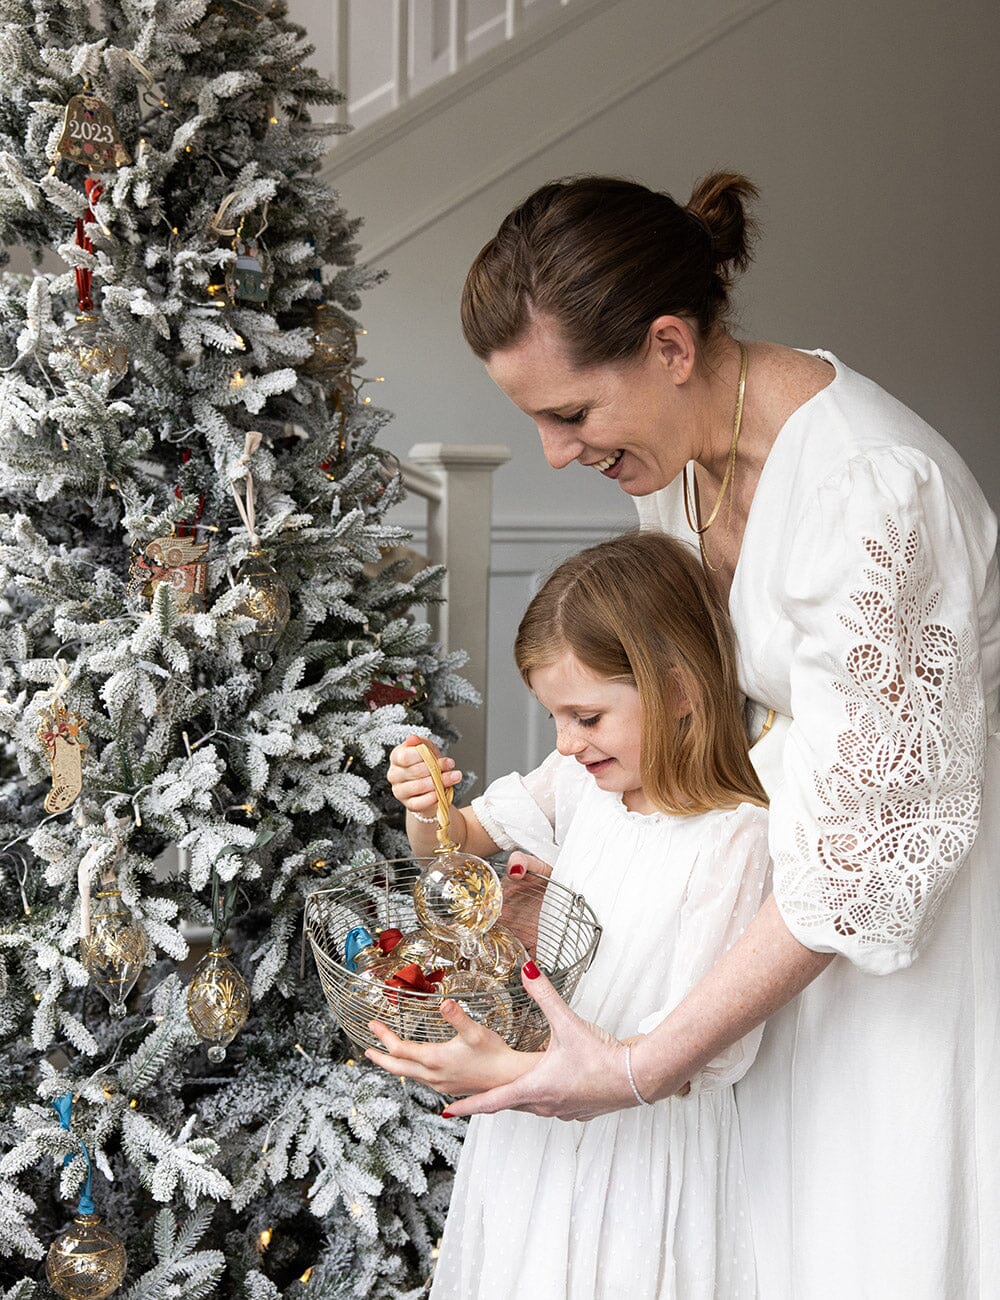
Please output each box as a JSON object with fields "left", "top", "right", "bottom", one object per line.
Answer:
{"left": 771, "top": 449, "right": 992, "bottom": 974}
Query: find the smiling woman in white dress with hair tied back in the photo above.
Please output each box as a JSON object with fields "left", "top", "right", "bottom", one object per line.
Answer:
{"left": 392, "top": 174, "right": 1000, "bottom": 1300}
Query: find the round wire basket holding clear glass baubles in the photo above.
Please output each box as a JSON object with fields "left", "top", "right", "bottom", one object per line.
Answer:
{"left": 303, "top": 858, "right": 601, "bottom": 1052}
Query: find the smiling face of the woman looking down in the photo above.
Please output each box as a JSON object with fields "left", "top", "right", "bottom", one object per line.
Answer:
{"left": 486, "top": 319, "right": 689, "bottom": 497}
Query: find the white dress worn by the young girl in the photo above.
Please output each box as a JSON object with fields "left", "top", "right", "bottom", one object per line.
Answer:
{"left": 430, "top": 754, "right": 769, "bottom": 1300}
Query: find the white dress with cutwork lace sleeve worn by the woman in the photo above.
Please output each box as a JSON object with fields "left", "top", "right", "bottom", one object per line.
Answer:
{"left": 637, "top": 352, "right": 1000, "bottom": 1300}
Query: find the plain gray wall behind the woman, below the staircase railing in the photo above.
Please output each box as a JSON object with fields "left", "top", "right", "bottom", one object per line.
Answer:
{"left": 315, "top": 0, "right": 1000, "bottom": 775}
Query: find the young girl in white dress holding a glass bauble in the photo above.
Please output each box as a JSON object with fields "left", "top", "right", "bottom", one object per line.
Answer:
{"left": 368, "top": 533, "right": 769, "bottom": 1300}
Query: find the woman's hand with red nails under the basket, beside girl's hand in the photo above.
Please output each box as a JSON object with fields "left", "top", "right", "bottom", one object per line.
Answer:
{"left": 447, "top": 963, "right": 637, "bottom": 1119}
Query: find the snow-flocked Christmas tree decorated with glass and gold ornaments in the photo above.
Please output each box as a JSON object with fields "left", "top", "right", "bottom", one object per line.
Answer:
{"left": 0, "top": 0, "right": 467, "bottom": 1300}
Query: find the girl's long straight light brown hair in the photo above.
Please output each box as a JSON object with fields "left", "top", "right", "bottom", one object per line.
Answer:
{"left": 514, "top": 533, "right": 767, "bottom": 815}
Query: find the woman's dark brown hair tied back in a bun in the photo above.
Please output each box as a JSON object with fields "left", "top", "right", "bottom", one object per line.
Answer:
{"left": 462, "top": 172, "right": 757, "bottom": 368}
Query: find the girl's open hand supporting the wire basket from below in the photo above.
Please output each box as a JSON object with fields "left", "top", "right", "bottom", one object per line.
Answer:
{"left": 364, "top": 998, "right": 541, "bottom": 1110}
